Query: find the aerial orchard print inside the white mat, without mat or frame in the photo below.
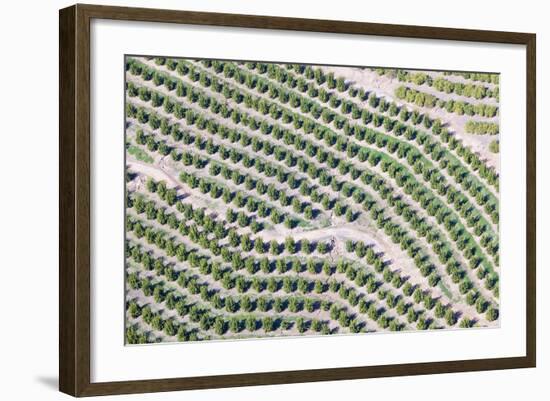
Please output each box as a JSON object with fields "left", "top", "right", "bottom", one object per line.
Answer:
{"left": 121, "top": 55, "right": 500, "bottom": 345}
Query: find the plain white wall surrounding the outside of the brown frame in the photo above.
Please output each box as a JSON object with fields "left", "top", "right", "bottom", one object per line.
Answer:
{"left": 0, "top": 0, "right": 550, "bottom": 401}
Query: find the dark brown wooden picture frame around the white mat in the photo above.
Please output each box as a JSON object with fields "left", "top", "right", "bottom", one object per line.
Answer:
{"left": 59, "top": 4, "right": 536, "bottom": 396}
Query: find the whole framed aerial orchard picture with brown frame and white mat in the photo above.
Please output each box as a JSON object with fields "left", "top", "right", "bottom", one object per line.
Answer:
{"left": 59, "top": 5, "right": 536, "bottom": 396}
